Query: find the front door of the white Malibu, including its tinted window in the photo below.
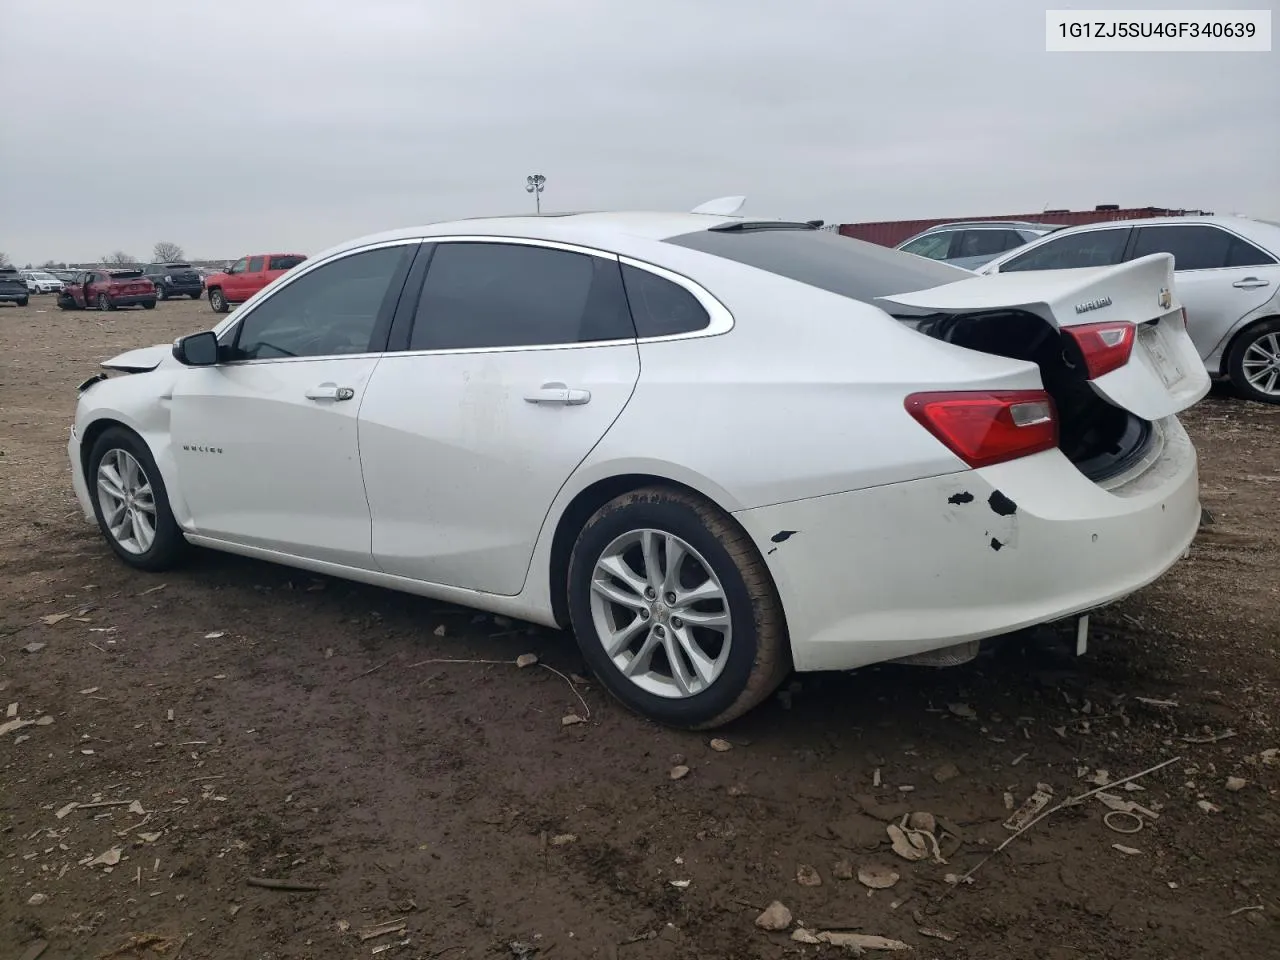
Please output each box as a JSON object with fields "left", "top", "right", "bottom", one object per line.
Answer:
{"left": 170, "top": 243, "right": 416, "bottom": 568}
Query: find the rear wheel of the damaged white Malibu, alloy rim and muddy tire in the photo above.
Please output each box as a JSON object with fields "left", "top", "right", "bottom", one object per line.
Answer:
{"left": 568, "top": 486, "right": 791, "bottom": 728}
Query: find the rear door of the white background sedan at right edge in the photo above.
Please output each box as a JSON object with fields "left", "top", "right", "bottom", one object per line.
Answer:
{"left": 1128, "top": 223, "right": 1280, "bottom": 360}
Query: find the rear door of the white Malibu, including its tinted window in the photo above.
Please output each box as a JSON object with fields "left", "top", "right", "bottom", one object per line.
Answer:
{"left": 360, "top": 238, "right": 640, "bottom": 595}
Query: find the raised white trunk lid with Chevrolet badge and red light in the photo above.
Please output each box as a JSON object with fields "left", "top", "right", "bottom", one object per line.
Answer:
{"left": 881, "top": 253, "right": 1210, "bottom": 421}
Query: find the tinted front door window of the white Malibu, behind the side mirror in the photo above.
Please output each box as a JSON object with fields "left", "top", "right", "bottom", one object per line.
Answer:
{"left": 233, "top": 244, "right": 412, "bottom": 360}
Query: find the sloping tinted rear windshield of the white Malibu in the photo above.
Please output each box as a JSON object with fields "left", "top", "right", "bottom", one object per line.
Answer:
{"left": 664, "top": 228, "right": 973, "bottom": 303}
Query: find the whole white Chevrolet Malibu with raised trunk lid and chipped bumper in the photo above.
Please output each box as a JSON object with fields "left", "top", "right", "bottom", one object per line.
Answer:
{"left": 68, "top": 206, "right": 1208, "bottom": 727}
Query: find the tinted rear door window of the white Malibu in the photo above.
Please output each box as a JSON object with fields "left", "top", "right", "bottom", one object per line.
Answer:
{"left": 408, "top": 243, "right": 636, "bottom": 349}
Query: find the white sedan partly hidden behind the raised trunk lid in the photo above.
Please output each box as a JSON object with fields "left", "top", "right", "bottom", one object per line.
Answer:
{"left": 978, "top": 216, "right": 1280, "bottom": 403}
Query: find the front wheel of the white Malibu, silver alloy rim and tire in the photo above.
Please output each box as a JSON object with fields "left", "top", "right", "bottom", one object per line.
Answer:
{"left": 86, "top": 426, "right": 187, "bottom": 571}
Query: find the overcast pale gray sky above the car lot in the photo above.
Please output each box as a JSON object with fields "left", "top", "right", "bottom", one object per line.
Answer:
{"left": 0, "top": 0, "right": 1280, "bottom": 264}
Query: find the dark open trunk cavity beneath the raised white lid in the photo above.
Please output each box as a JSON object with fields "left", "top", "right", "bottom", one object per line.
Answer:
{"left": 899, "top": 310, "right": 1152, "bottom": 481}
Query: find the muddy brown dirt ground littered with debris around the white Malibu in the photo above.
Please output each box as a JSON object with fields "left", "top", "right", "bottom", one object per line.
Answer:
{"left": 0, "top": 297, "right": 1280, "bottom": 960}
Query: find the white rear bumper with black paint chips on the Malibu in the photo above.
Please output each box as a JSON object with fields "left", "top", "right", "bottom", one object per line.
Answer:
{"left": 735, "top": 417, "right": 1201, "bottom": 671}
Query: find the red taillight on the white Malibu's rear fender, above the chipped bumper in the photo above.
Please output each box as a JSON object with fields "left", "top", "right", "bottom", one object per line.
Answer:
{"left": 906, "top": 390, "right": 1057, "bottom": 467}
